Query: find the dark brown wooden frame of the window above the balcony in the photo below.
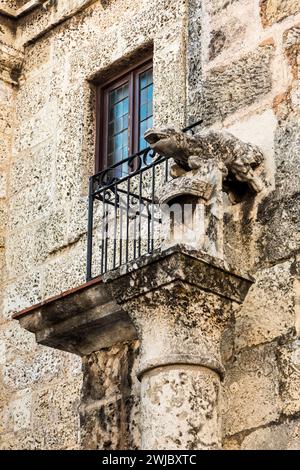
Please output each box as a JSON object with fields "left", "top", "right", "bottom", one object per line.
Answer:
{"left": 95, "top": 55, "right": 153, "bottom": 173}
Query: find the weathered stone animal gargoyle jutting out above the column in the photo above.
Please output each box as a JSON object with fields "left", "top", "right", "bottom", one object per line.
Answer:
{"left": 144, "top": 128, "right": 264, "bottom": 193}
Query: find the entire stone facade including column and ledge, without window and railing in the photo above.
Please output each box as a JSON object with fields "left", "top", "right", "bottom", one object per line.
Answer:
{"left": 0, "top": 0, "right": 300, "bottom": 450}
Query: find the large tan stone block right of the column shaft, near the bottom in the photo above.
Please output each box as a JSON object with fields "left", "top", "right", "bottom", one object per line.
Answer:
{"left": 222, "top": 343, "right": 281, "bottom": 435}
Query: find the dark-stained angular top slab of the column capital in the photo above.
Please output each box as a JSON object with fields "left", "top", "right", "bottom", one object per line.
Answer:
{"left": 103, "top": 245, "right": 254, "bottom": 303}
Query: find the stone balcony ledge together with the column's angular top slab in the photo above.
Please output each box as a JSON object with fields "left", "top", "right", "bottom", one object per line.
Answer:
{"left": 14, "top": 245, "right": 253, "bottom": 355}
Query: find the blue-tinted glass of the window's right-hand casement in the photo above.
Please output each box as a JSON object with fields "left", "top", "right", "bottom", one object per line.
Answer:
{"left": 139, "top": 69, "right": 153, "bottom": 150}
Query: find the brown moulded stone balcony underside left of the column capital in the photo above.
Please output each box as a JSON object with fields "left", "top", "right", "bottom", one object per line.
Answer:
{"left": 13, "top": 278, "right": 136, "bottom": 355}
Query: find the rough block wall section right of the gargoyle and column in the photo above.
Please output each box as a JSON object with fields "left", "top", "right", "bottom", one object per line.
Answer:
{"left": 195, "top": 0, "right": 300, "bottom": 449}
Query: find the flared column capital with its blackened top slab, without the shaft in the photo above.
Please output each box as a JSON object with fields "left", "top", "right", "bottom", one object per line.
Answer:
{"left": 105, "top": 245, "right": 253, "bottom": 377}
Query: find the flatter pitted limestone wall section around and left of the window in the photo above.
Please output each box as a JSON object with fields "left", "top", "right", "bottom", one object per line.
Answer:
{"left": 0, "top": 0, "right": 186, "bottom": 449}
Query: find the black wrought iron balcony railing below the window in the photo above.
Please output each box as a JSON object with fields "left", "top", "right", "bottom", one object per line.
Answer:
{"left": 87, "top": 121, "right": 201, "bottom": 281}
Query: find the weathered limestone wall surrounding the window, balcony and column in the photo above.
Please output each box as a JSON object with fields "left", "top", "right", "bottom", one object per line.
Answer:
{"left": 0, "top": 0, "right": 300, "bottom": 449}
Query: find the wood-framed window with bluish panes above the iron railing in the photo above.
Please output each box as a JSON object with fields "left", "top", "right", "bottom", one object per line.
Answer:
{"left": 96, "top": 61, "right": 153, "bottom": 176}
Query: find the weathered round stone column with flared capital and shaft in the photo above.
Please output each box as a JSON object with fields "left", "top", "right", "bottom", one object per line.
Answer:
{"left": 110, "top": 246, "right": 251, "bottom": 450}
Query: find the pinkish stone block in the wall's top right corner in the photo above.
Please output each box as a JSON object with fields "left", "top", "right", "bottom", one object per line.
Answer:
{"left": 260, "top": 0, "right": 300, "bottom": 27}
